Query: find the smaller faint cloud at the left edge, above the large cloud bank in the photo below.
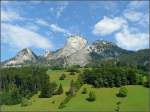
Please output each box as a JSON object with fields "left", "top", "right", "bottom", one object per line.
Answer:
{"left": 1, "top": 9, "right": 23, "bottom": 22}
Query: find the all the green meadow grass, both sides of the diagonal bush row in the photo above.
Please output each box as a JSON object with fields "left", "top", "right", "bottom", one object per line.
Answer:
{"left": 2, "top": 70, "right": 149, "bottom": 112}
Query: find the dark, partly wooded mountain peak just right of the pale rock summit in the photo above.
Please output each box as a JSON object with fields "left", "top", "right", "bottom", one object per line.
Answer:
{"left": 89, "top": 40, "right": 133, "bottom": 60}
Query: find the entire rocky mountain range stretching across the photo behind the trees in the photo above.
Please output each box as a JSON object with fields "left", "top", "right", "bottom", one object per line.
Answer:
{"left": 2, "top": 36, "right": 149, "bottom": 67}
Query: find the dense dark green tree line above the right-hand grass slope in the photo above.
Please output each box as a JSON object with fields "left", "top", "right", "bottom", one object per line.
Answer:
{"left": 81, "top": 66, "right": 148, "bottom": 87}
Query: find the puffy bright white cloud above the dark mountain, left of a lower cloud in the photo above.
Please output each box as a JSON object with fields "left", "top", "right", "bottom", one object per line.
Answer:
{"left": 93, "top": 16, "right": 126, "bottom": 36}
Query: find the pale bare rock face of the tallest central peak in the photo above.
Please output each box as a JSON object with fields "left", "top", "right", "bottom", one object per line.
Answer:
{"left": 45, "top": 36, "right": 88, "bottom": 66}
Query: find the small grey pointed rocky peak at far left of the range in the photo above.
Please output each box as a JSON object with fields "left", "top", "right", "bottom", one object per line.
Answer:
{"left": 4, "top": 48, "right": 38, "bottom": 67}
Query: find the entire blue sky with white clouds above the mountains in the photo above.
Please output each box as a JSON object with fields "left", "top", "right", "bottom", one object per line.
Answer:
{"left": 1, "top": 1, "right": 149, "bottom": 61}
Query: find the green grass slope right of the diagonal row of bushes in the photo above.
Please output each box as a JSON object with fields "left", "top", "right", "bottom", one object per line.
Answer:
{"left": 64, "top": 85, "right": 149, "bottom": 112}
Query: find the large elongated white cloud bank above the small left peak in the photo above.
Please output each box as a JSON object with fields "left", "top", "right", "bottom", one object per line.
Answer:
{"left": 1, "top": 23, "right": 52, "bottom": 49}
